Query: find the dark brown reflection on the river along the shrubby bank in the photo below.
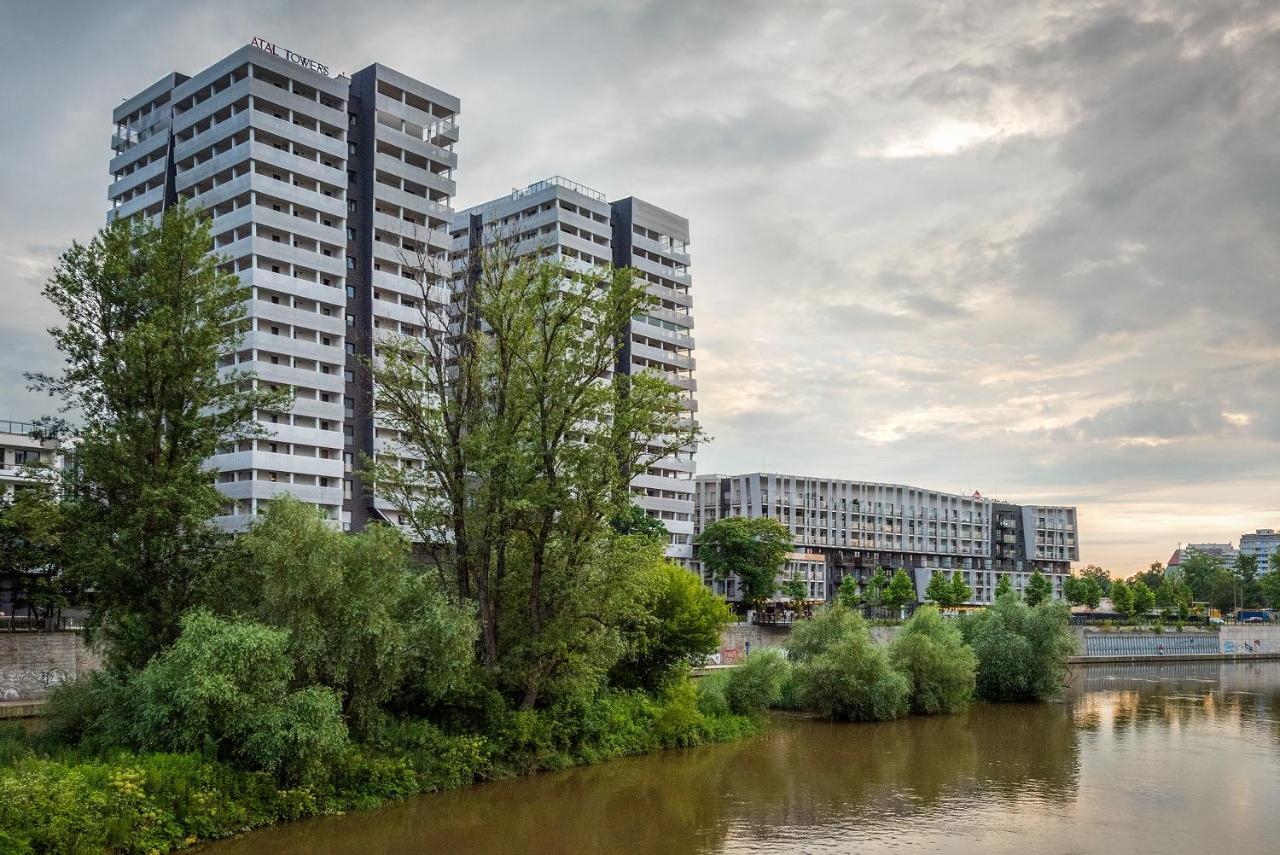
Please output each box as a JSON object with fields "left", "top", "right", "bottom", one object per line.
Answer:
{"left": 214, "top": 704, "right": 1078, "bottom": 855}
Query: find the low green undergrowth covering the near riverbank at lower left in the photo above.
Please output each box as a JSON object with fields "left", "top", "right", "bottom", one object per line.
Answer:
{"left": 0, "top": 682, "right": 763, "bottom": 855}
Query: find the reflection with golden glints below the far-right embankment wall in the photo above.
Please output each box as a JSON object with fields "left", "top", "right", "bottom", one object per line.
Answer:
{"left": 1073, "top": 662, "right": 1280, "bottom": 736}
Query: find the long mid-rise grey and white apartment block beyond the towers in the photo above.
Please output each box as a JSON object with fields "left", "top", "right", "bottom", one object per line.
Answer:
{"left": 694, "top": 472, "right": 1080, "bottom": 603}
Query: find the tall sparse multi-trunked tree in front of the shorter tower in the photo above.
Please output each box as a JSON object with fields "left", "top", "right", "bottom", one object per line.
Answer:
{"left": 365, "top": 245, "right": 705, "bottom": 709}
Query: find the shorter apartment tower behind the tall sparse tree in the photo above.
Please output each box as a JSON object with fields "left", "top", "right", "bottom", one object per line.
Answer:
{"left": 453, "top": 175, "right": 698, "bottom": 564}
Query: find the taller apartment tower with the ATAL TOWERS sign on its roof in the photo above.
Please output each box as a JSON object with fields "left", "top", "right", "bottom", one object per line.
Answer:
{"left": 108, "top": 45, "right": 460, "bottom": 530}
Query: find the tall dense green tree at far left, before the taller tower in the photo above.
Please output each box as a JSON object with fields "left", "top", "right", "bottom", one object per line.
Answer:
{"left": 27, "top": 206, "right": 285, "bottom": 668}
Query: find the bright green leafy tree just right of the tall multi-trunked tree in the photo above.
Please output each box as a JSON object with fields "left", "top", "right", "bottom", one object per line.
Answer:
{"left": 611, "top": 561, "right": 731, "bottom": 691}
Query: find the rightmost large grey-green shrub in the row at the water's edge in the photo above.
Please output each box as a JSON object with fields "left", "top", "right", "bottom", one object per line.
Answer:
{"left": 960, "top": 598, "right": 1075, "bottom": 701}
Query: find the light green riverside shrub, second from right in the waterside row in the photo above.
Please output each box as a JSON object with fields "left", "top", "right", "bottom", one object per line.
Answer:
{"left": 890, "top": 607, "right": 978, "bottom": 714}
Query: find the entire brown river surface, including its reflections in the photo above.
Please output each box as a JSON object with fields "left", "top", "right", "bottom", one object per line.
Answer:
{"left": 202, "top": 662, "right": 1280, "bottom": 855}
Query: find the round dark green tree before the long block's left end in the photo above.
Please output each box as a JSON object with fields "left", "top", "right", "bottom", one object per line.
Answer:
{"left": 696, "top": 517, "right": 792, "bottom": 605}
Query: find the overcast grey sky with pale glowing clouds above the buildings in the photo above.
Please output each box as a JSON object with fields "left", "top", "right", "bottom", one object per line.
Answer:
{"left": 0, "top": 0, "right": 1280, "bottom": 573}
